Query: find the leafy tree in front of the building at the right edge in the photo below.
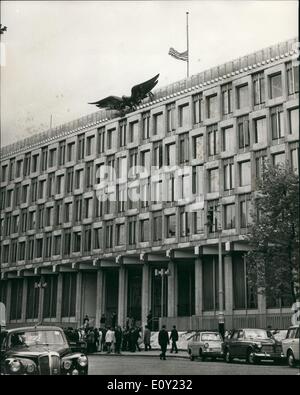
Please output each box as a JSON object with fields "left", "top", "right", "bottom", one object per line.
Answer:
{"left": 247, "top": 163, "right": 300, "bottom": 303}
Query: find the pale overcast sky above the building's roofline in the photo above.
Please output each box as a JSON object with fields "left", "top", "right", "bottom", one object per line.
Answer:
{"left": 1, "top": 0, "right": 298, "bottom": 146}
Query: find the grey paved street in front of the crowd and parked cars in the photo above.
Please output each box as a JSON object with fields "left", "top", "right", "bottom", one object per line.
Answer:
{"left": 89, "top": 355, "right": 299, "bottom": 375}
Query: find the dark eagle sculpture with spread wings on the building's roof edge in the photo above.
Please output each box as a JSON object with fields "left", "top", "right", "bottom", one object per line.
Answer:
{"left": 88, "top": 74, "right": 159, "bottom": 114}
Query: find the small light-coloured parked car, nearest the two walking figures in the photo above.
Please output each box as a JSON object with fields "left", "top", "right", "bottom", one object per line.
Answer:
{"left": 187, "top": 331, "right": 223, "bottom": 361}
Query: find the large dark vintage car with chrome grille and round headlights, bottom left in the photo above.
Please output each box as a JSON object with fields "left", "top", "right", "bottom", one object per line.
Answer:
{"left": 0, "top": 326, "right": 88, "bottom": 375}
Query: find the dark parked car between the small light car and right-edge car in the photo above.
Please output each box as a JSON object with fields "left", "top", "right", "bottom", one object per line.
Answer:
{"left": 224, "top": 328, "right": 285, "bottom": 364}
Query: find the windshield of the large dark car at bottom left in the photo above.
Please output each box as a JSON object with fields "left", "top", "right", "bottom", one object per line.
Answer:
{"left": 9, "top": 330, "right": 65, "bottom": 347}
